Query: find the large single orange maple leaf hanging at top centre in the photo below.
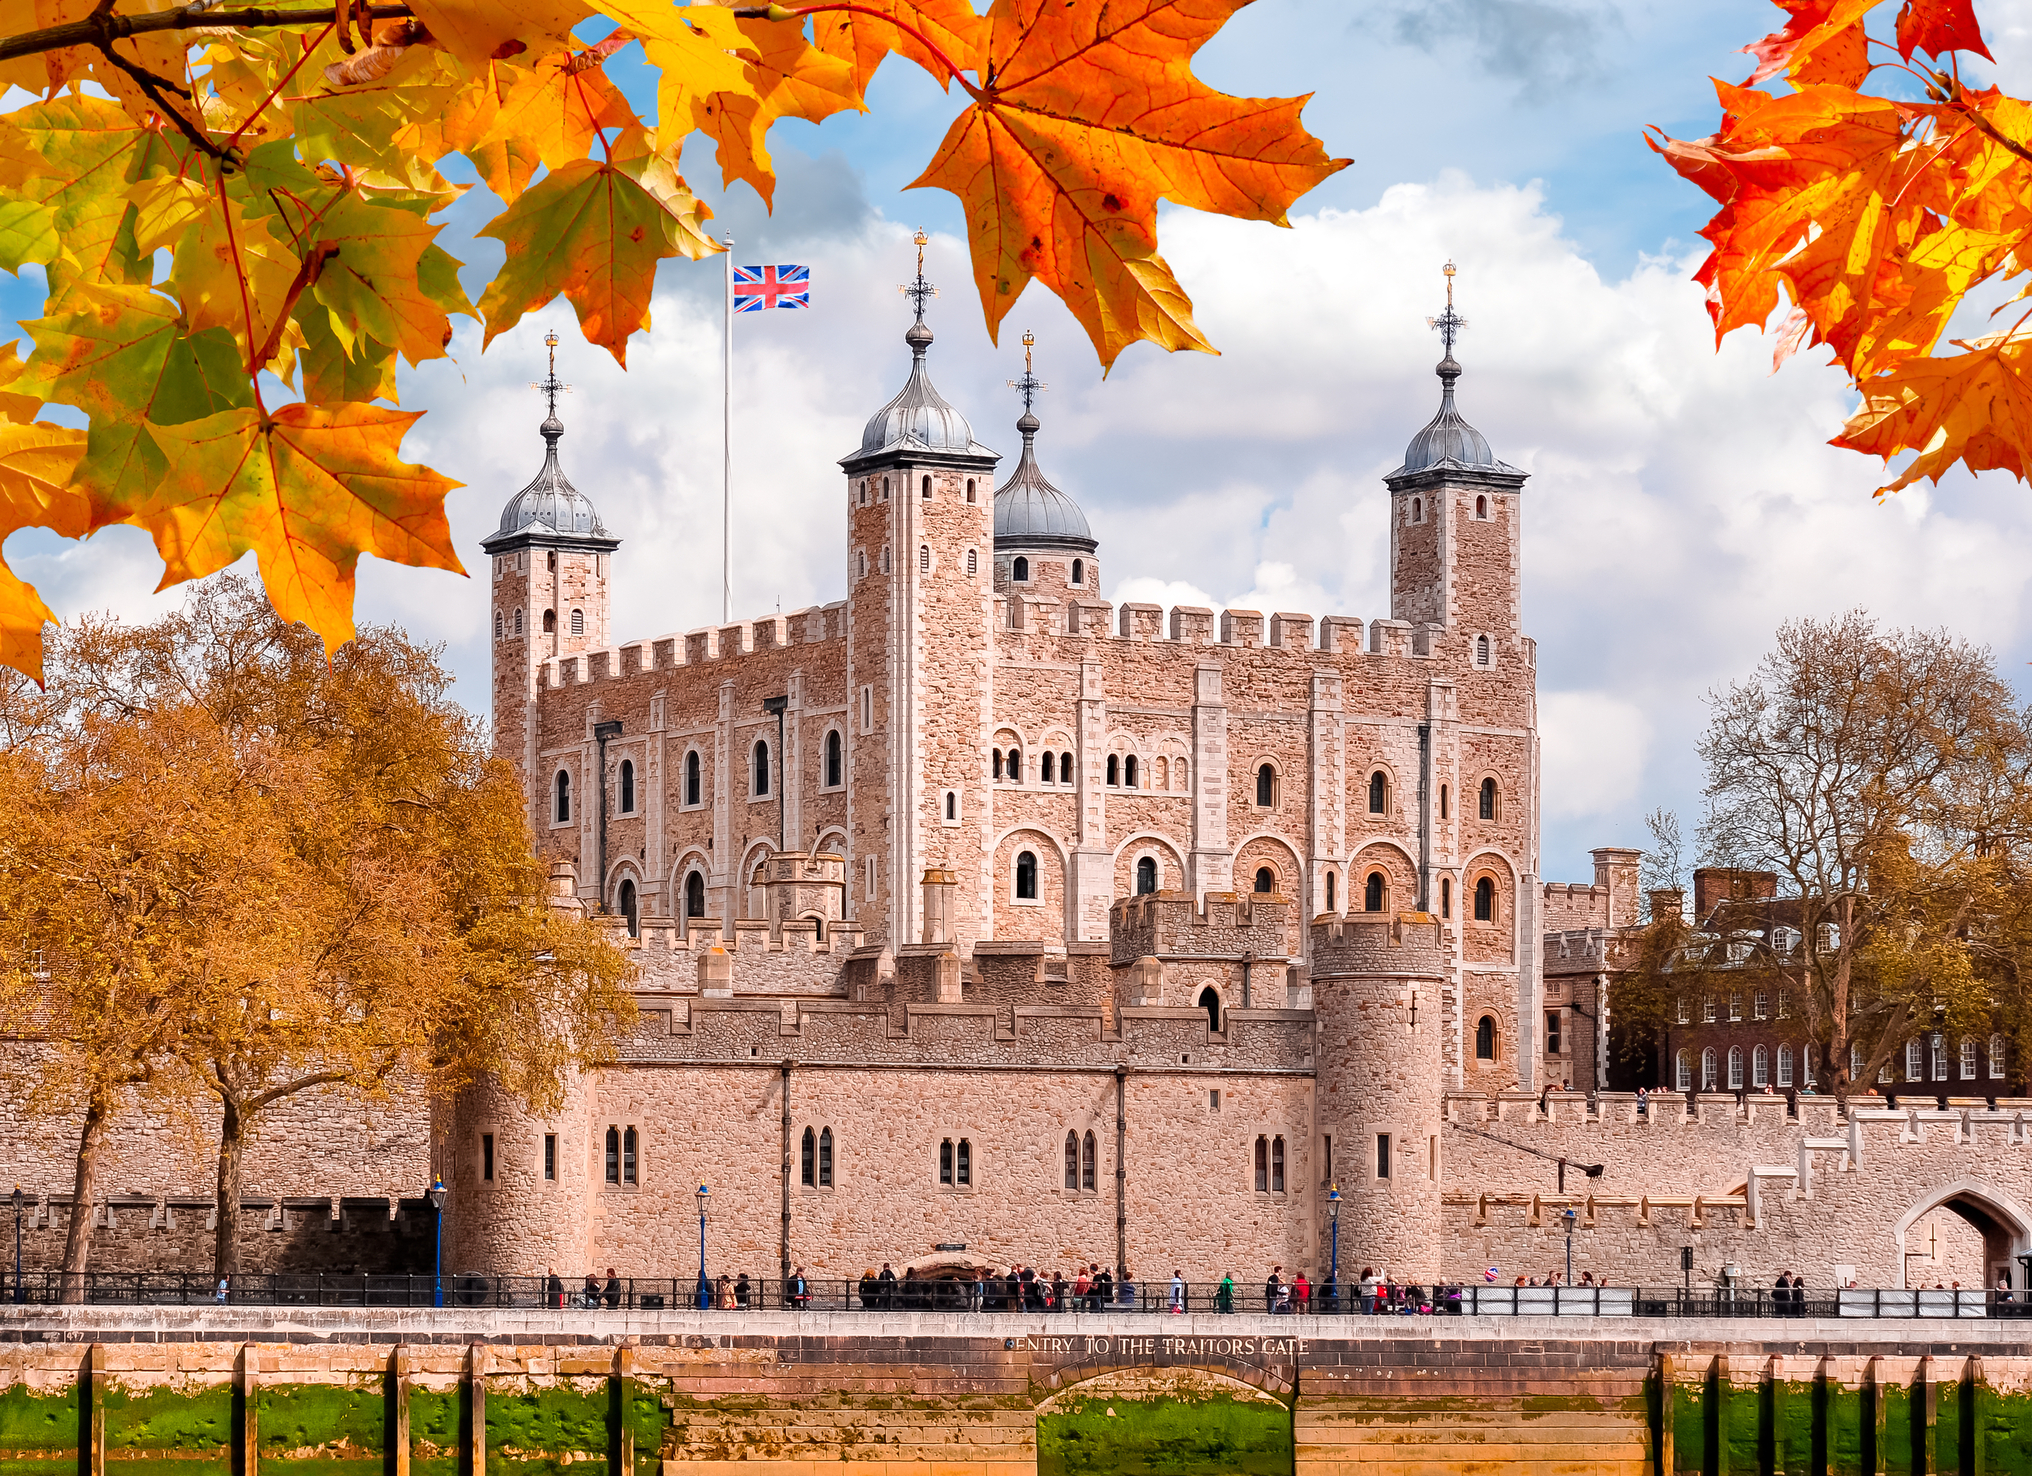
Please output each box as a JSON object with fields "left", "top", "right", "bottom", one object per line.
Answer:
{"left": 912, "top": 0, "right": 1349, "bottom": 366}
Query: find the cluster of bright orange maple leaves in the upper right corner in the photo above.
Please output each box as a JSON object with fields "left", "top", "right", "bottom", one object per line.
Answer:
{"left": 1650, "top": 0, "right": 2032, "bottom": 496}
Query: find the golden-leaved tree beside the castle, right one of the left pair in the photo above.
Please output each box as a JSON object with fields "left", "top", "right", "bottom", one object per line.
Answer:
{"left": 6, "top": 577, "right": 632, "bottom": 1275}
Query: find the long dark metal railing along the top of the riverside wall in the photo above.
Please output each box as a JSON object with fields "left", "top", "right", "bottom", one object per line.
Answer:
{"left": 0, "top": 1271, "right": 2032, "bottom": 1321}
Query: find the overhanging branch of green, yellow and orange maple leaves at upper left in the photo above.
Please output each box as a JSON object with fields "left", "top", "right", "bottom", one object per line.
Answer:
{"left": 0, "top": 0, "right": 1347, "bottom": 675}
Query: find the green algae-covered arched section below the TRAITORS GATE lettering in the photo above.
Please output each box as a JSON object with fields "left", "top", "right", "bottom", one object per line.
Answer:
{"left": 1036, "top": 1395, "right": 1292, "bottom": 1476}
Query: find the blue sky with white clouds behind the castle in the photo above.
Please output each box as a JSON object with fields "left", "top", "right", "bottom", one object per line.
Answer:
{"left": 0, "top": 0, "right": 2032, "bottom": 878}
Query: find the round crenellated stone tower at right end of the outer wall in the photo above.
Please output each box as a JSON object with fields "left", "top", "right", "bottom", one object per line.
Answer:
{"left": 1313, "top": 913, "right": 1453, "bottom": 1285}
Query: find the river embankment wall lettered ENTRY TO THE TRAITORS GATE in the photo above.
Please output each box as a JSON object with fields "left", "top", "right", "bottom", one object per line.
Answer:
{"left": 0, "top": 1307, "right": 2032, "bottom": 1476}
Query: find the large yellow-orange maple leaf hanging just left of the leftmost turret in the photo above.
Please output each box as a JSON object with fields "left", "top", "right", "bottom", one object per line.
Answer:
{"left": 124, "top": 405, "right": 465, "bottom": 651}
